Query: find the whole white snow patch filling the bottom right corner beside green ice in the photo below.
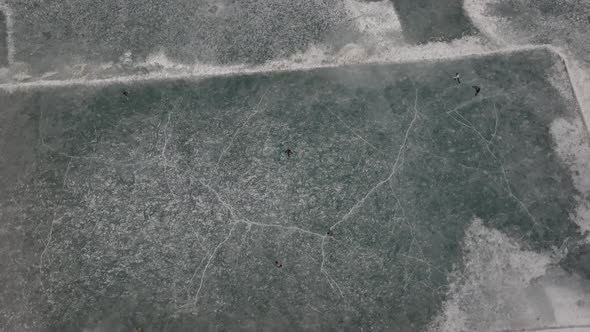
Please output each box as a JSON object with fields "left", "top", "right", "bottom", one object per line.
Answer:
{"left": 428, "top": 219, "right": 590, "bottom": 332}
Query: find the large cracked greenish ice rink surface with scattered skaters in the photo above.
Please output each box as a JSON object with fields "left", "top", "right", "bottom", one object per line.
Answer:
{"left": 0, "top": 50, "right": 581, "bottom": 331}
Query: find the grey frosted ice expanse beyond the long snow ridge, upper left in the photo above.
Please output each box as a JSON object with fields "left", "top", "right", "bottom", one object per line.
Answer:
{"left": 6, "top": 0, "right": 355, "bottom": 72}
